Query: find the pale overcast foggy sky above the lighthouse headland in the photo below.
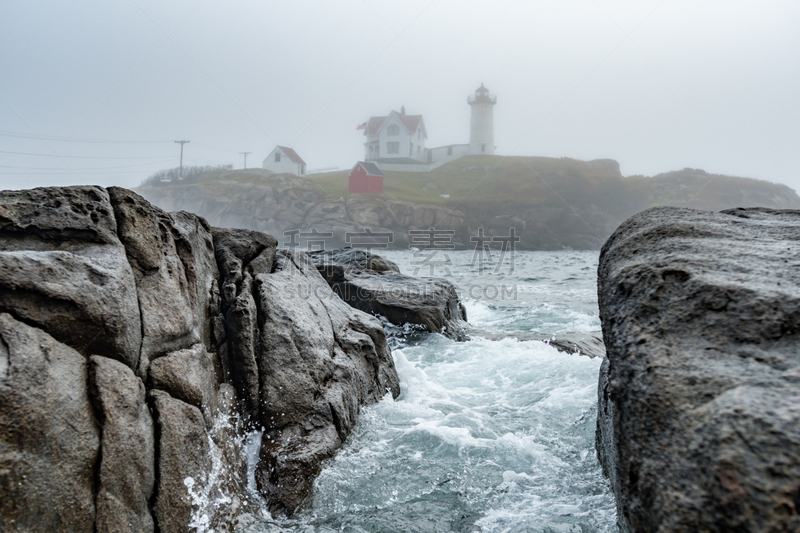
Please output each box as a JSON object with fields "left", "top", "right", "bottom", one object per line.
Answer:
{"left": 0, "top": 0, "right": 800, "bottom": 193}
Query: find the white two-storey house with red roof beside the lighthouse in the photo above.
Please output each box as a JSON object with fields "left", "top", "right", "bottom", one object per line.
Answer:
{"left": 362, "top": 107, "right": 428, "bottom": 163}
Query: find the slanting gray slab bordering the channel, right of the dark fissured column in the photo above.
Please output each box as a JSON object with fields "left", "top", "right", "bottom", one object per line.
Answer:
{"left": 255, "top": 251, "right": 400, "bottom": 514}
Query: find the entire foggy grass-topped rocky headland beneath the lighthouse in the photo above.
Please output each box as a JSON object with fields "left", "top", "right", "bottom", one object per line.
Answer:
{"left": 137, "top": 156, "right": 800, "bottom": 250}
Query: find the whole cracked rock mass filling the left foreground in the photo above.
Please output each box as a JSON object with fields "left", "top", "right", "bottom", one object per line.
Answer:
{"left": 0, "top": 187, "right": 399, "bottom": 533}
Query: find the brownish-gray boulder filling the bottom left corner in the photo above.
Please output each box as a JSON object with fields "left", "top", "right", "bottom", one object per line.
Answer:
{"left": 0, "top": 313, "right": 100, "bottom": 533}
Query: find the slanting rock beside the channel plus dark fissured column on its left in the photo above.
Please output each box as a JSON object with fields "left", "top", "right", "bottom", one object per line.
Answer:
{"left": 213, "top": 236, "right": 400, "bottom": 514}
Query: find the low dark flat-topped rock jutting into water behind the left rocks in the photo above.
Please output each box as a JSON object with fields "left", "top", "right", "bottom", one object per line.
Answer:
{"left": 309, "top": 249, "right": 468, "bottom": 340}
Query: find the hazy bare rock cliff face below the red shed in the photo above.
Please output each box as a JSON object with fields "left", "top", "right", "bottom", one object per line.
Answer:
{"left": 139, "top": 174, "right": 470, "bottom": 249}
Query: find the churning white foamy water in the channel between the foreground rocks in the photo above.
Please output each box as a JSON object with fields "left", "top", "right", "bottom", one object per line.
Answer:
{"left": 296, "top": 332, "right": 614, "bottom": 531}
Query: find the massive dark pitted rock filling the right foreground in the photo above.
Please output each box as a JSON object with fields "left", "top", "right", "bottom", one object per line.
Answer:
{"left": 597, "top": 208, "right": 800, "bottom": 532}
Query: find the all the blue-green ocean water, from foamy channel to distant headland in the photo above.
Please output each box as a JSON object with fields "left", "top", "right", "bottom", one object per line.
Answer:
{"left": 201, "top": 251, "right": 616, "bottom": 533}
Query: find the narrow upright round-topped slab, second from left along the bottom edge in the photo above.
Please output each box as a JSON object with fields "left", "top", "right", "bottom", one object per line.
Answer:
{"left": 89, "top": 356, "right": 155, "bottom": 533}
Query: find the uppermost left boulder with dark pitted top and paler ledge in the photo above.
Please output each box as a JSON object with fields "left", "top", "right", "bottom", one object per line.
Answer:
{"left": 0, "top": 187, "right": 141, "bottom": 368}
